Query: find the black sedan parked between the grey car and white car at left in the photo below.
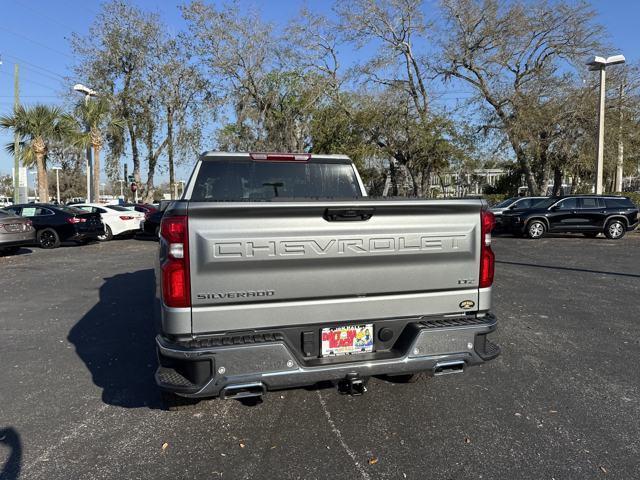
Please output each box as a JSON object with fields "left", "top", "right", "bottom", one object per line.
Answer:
{"left": 6, "top": 203, "right": 104, "bottom": 248}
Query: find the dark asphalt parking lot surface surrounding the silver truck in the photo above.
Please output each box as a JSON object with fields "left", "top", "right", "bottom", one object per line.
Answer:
{"left": 0, "top": 234, "right": 640, "bottom": 480}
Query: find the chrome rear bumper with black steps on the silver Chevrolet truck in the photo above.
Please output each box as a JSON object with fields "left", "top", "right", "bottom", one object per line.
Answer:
{"left": 155, "top": 315, "right": 500, "bottom": 398}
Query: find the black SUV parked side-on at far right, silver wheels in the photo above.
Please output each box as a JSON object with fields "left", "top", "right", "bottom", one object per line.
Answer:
{"left": 502, "top": 195, "right": 638, "bottom": 240}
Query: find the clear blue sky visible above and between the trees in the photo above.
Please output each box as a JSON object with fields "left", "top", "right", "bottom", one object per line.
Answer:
{"left": 0, "top": 0, "right": 640, "bottom": 181}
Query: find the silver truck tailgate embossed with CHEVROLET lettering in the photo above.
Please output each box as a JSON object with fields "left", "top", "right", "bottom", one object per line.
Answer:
{"left": 188, "top": 200, "right": 488, "bottom": 334}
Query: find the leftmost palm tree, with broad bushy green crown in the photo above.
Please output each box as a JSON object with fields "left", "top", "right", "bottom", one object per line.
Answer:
{"left": 0, "top": 104, "right": 73, "bottom": 202}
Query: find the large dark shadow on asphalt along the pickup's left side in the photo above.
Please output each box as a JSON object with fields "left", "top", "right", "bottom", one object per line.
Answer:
{"left": 68, "top": 269, "right": 160, "bottom": 408}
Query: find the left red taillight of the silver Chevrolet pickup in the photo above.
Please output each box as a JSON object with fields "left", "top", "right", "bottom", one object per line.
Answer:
{"left": 160, "top": 216, "right": 191, "bottom": 307}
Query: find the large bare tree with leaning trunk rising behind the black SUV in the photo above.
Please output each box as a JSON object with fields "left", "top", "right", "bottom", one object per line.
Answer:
{"left": 434, "top": 0, "right": 602, "bottom": 194}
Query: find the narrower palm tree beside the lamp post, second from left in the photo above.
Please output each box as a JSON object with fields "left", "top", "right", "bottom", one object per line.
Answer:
{"left": 76, "top": 97, "right": 124, "bottom": 201}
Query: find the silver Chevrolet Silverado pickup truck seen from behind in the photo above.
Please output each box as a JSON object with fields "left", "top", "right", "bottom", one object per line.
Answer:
{"left": 156, "top": 152, "right": 500, "bottom": 404}
